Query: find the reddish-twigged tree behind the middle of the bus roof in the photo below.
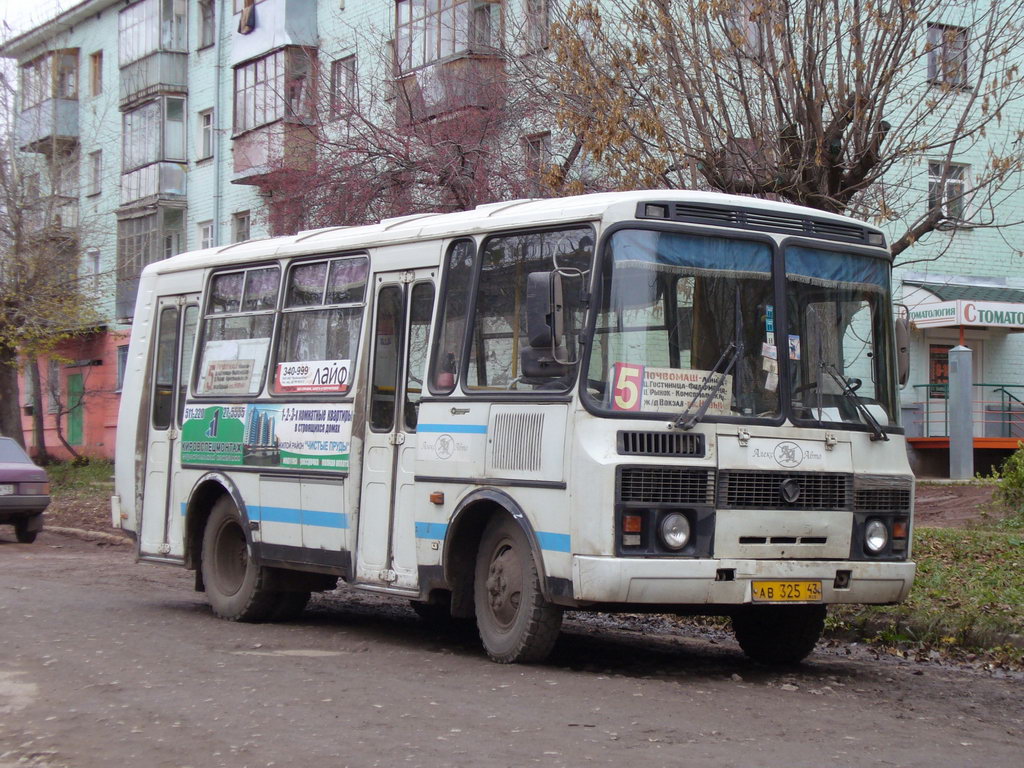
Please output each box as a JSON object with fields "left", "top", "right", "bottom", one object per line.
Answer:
{"left": 250, "top": 12, "right": 591, "bottom": 233}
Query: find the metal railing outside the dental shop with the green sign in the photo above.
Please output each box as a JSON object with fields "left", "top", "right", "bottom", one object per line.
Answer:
{"left": 904, "top": 382, "right": 1024, "bottom": 439}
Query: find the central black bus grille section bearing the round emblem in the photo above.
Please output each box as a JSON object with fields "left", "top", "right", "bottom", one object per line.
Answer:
{"left": 718, "top": 471, "right": 853, "bottom": 510}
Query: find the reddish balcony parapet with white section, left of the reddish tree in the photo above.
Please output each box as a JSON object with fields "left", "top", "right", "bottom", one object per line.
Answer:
{"left": 231, "top": 120, "right": 316, "bottom": 184}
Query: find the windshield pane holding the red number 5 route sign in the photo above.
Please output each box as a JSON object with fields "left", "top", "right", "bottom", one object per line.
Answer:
{"left": 588, "top": 229, "right": 779, "bottom": 419}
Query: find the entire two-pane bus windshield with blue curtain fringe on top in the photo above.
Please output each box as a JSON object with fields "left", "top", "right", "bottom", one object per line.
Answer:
{"left": 587, "top": 229, "right": 896, "bottom": 431}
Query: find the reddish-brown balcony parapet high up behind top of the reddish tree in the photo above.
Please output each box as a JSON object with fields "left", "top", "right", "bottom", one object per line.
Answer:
{"left": 395, "top": 54, "right": 507, "bottom": 125}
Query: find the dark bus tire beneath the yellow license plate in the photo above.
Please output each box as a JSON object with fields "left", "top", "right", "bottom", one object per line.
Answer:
{"left": 732, "top": 605, "right": 825, "bottom": 666}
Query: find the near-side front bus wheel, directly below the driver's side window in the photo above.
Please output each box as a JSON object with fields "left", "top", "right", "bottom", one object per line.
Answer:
{"left": 473, "top": 515, "right": 562, "bottom": 664}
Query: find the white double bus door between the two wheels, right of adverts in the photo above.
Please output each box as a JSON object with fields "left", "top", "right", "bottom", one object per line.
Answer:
{"left": 356, "top": 269, "right": 435, "bottom": 591}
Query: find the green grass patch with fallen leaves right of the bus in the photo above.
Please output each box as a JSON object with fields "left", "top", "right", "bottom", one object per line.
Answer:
{"left": 829, "top": 528, "right": 1024, "bottom": 664}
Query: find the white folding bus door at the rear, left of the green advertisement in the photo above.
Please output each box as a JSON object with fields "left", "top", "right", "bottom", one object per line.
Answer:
{"left": 139, "top": 294, "right": 199, "bottom": 560}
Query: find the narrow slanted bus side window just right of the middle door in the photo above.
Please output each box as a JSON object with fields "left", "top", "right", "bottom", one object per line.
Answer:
{"left": 430, "top": 240, "right": 475, "bottom": 394}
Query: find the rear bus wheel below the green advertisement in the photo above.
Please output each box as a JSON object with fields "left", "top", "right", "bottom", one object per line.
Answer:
{"left": 203, "top": 495, "right": 281, "bottom": 622}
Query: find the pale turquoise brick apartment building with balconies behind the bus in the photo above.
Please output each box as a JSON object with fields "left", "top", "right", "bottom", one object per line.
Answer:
{"left": 0, "top": 0, "right": 1024, "bottom": 474}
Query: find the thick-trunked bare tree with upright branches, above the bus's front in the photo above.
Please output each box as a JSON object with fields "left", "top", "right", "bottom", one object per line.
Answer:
{"left": 547, "top": 0, "right": 1024, "bottom": 260}
